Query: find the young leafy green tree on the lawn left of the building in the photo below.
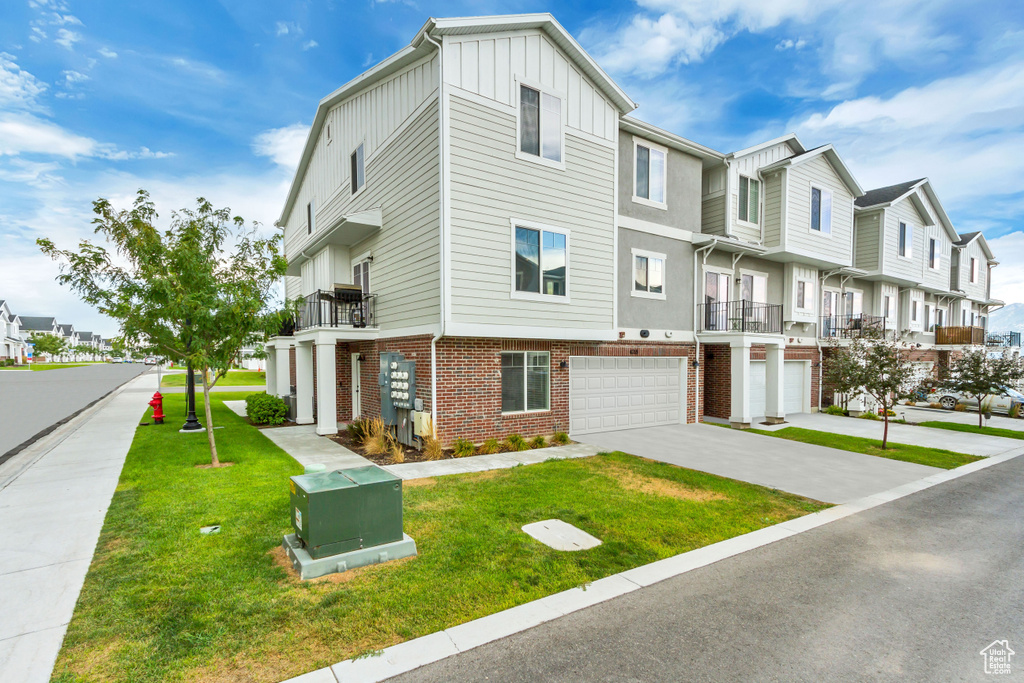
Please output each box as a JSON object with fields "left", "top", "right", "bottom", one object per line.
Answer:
{"left": 38, "top": 189, "right": 287, "bottom": 467}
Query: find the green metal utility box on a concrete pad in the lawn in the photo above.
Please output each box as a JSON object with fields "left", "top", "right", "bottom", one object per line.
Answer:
{"left": 291, "top": 465, "right": 402, "bottom": 559}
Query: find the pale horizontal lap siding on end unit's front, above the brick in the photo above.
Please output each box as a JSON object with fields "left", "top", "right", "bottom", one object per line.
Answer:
{"left": 450, "top": 94, "right": 615, "bottom": 329}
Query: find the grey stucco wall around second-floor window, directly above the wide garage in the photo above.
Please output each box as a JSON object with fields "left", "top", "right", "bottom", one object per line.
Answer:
{"left": 618, "top": 227, "right": 693, "bottom": 330}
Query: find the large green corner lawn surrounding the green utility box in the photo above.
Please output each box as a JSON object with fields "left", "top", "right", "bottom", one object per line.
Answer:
{"left": 53, "top": 393, "right": 827, "bottom": 682}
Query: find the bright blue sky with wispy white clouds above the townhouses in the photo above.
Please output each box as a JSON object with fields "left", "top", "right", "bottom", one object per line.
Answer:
{"left": 0, "top": 0, "right": 1024, "bottom": 334}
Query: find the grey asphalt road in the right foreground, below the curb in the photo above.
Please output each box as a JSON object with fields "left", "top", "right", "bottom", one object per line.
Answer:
{"left": 392, "top": 457, "right": 1024, "bottom": 683}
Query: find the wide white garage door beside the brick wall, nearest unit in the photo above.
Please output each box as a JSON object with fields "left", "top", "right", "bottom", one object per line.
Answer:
{"left": 569, "top": 356, "right": 686, "bottom": 434}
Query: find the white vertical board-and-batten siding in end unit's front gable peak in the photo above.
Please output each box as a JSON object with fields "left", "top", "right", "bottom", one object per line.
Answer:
{"left": 443, "top": 31, "right": 618, "bottom": 141}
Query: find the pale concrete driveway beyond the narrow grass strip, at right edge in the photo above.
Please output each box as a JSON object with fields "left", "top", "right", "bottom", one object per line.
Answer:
{"left": 770, "top": 413, "right": 1021, "bottom": 457}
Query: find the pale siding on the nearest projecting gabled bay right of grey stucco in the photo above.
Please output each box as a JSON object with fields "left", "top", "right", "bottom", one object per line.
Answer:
{"left": 785, "top": 155, "right": 853, "bottom": 266}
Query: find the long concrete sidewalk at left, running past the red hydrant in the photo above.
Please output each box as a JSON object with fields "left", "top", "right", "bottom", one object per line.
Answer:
{"left": 0, "top": 377, "right": 153, "bottom": 683}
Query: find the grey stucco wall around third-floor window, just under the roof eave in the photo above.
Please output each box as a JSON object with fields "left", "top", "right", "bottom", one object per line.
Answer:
{"left": 618, "top": 131, "right": 702, "bottom": 232}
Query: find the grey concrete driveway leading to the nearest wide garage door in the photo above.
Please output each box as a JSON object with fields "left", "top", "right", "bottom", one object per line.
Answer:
{"left": 572, "top": 421, "right": 942, "bottom": 503}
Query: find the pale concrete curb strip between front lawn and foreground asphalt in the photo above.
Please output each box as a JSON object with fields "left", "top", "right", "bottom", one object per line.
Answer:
{"left": 284, "top": 447, "right": 1024, "bottom": 683}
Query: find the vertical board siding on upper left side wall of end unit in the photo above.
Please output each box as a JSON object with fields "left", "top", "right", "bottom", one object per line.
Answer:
{"left": 285, "top": 53, "right": 439, "bottom": 256}
